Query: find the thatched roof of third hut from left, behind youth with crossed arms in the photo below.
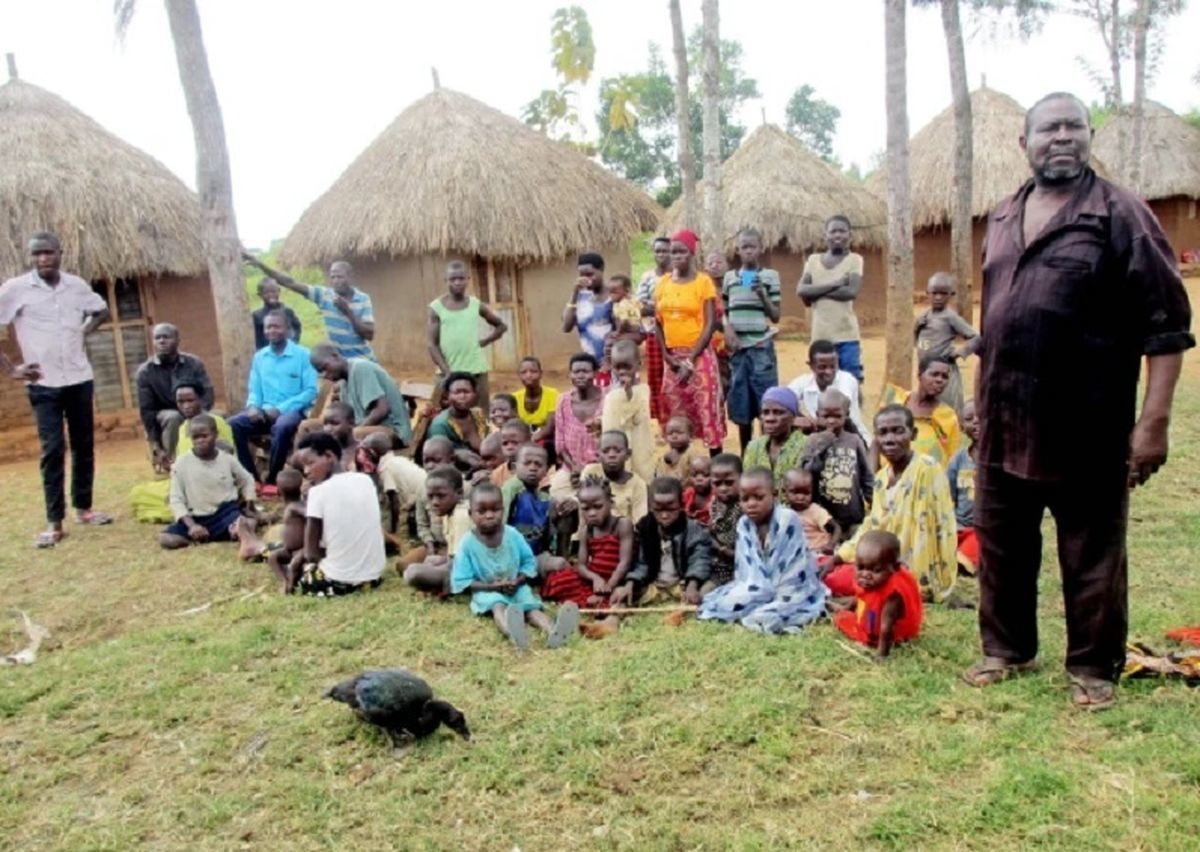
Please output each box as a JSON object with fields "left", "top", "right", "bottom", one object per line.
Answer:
{"left": 664, "top": 125, "right": 887, "bottom": 252}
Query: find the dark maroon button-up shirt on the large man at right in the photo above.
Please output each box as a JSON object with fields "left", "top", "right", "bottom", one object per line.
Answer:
{"left": 978, "top": 169, "right": 1195, "bottom": 481}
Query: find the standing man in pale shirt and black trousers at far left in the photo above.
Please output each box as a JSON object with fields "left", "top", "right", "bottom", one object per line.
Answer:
{"left": 0, "top": 230, "right": 113, "bottom": 547}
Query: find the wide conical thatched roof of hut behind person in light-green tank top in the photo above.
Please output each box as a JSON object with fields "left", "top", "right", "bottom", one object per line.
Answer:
{"left": 281, "top": 89, "right": 661, "bottom": 264}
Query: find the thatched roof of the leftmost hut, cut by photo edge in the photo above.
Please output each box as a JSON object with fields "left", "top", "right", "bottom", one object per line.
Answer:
{"left": 0, "top": 79, "right": 206, "bottom": 280}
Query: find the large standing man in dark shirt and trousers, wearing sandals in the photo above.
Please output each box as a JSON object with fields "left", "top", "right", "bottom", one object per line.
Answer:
{"left": 965, "top": 92, "right": 1195, "bottom": 710}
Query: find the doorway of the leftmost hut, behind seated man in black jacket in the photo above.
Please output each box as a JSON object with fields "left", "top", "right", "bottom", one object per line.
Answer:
{"left": 86, "top": 278, "right": 150, "bottom": 412}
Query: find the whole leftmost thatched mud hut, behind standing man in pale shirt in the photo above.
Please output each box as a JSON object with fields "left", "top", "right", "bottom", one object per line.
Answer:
{"left": 0, "top": 79, "right": 220, "bottom": 458}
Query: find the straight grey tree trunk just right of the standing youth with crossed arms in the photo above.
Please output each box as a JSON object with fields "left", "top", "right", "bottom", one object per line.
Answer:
{"left": 883, "top": 0, "right": 913, "bottom": 388}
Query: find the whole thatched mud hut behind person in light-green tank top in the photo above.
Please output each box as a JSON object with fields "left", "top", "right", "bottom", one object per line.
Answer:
{"left": 281, "top": 89, "right": 660, "bottom": 376}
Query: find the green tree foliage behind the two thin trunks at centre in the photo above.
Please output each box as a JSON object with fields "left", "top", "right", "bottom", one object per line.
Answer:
{"left": 596, "top": 33, "right": 758, "bottom": 205}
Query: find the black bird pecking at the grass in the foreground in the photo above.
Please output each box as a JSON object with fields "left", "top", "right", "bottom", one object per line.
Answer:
{"left": 324, "top": 668, "right": 470, "bottom": 748}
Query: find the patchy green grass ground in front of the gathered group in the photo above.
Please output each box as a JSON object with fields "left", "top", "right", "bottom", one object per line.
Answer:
{"left": 7, "top": 290, "right": 1200, "bottom": 851}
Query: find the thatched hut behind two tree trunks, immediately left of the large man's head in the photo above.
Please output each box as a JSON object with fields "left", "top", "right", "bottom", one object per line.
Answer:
{"left": 866, "top": 86, "right": 1030, "bottom": 295}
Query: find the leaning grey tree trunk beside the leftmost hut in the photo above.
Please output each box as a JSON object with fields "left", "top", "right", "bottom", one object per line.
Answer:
{"left": 166, "top": 0, "right": 254, "bottom": 412}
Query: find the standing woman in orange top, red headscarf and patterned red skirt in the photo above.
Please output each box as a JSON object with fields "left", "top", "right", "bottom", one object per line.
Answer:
{"left": 654, "top": 230, "right": 725, "bottom": 451}
